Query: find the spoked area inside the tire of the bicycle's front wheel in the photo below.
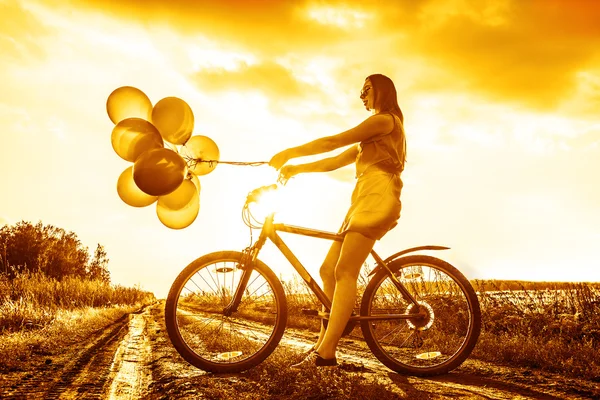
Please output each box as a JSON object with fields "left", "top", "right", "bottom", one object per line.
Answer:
{"left": 176, "top": 260, "right": 278, "bottom": 363}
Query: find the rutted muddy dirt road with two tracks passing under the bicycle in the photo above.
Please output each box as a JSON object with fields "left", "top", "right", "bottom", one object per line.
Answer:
{"left": 0, "top": 303, "right": 600, "bottom": 399}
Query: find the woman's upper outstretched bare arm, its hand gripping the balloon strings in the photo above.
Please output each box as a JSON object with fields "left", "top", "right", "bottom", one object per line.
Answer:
{"left": 269, "top": 114, "right": 393, "bottom": 169}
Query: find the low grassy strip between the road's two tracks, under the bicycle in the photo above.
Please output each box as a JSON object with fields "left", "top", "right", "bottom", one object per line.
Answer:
{"left": 150, "top": 304, "right": 420, "bottom": 400}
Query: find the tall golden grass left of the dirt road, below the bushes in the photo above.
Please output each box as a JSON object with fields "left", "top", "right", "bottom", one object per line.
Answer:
{"left": 0, "top": 274, "right": 155, "bottom": 370}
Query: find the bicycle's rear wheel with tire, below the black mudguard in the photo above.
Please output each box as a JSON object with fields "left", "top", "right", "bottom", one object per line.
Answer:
{"left": 361, "top": 255, "right": 481, "bottom": 376}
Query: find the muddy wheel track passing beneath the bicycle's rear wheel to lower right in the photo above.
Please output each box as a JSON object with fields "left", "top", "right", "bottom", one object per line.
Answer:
{"left": 280, "top": 329, "right": 600, "bottom": 400}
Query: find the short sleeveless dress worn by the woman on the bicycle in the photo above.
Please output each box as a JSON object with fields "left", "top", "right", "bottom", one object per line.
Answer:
{"left": 339, "top": 115, "right": 406, "bottom": 240}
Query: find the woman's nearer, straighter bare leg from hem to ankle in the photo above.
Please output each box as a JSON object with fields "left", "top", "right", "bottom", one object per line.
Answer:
{"left": 317, "top": 232, "right": 375, "bottom": 358}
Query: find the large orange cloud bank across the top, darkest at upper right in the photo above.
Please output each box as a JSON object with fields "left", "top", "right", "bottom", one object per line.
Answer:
{"left": 27, "top": 0, "right": 600, "bottom": 110}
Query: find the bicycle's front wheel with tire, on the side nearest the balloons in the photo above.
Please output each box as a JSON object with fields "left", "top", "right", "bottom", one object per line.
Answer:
{"left": 165, "top": 251, "right": 287, "bottom": 372}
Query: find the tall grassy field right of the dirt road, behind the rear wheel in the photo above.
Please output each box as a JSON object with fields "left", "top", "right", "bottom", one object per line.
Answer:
{"left": 284, "top": 280, "right": 600, "bottom": 381}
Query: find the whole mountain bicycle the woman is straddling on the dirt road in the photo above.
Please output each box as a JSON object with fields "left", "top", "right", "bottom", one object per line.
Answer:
{"left": 165, "top": 181, "right": 481, "bottom": 376}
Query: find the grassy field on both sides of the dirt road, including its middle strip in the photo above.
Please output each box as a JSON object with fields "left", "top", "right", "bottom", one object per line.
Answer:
{"left": 0, "top": 274, "right": 600, "bottom": 400}
